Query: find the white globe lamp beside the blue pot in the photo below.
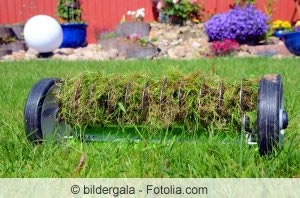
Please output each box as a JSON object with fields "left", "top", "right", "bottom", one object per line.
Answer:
{"left": 24, "top": 15, "right": 63, "bottom": 53}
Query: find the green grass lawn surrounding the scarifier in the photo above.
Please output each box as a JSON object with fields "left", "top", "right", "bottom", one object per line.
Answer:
{"left": 0, "top": 58, "right": 300, "bottom": 178}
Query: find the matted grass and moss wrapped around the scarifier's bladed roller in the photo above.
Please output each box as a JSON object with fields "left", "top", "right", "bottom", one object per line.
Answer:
{"left": 56, "top": 71, "right": 259, "bottom": 132}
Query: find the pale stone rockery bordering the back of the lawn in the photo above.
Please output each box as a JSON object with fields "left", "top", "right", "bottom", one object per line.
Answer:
{"left": 2, "top": 23, "right": 294, "bottom": 61}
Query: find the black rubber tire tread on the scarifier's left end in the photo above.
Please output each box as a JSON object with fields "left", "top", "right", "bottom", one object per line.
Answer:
{"left": 24, "top": 78, "right": 60, "bottom": 143}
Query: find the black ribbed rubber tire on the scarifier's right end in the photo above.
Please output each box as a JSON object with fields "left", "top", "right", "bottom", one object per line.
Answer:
{"left": 257, "top": 75, "right": 283, "bottom": 156}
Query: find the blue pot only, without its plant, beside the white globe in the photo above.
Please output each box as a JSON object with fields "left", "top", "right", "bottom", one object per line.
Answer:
{"left": 60, "top": 23, "right": 87, "bottom": 48}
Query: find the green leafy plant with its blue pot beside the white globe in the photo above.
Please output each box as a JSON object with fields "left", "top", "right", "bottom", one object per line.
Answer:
{"left": 57, "top": 0, "right": 87, "bottom": 48}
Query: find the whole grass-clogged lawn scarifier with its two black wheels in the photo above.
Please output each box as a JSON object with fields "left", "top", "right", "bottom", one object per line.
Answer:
{"left": 24, "top": 72, "right": 288, "bottom": 155}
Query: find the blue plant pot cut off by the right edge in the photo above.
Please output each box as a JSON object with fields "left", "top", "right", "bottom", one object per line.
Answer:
{"left": 281, "top": 32, "right": 300, "bottom": 56}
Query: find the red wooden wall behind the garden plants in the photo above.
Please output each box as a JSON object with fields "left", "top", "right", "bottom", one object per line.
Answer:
{"left": 0, "top": 0, "right": 298, "bottom": 43}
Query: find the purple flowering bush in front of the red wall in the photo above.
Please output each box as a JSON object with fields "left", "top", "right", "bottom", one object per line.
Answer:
{"left": 205, "top": 4, "right": 268, "bottom": 43}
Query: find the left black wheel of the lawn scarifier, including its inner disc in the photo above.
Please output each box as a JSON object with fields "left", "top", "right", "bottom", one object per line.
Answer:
{"left": 24, "top": 78, "right": 60, "bottom": 142}
